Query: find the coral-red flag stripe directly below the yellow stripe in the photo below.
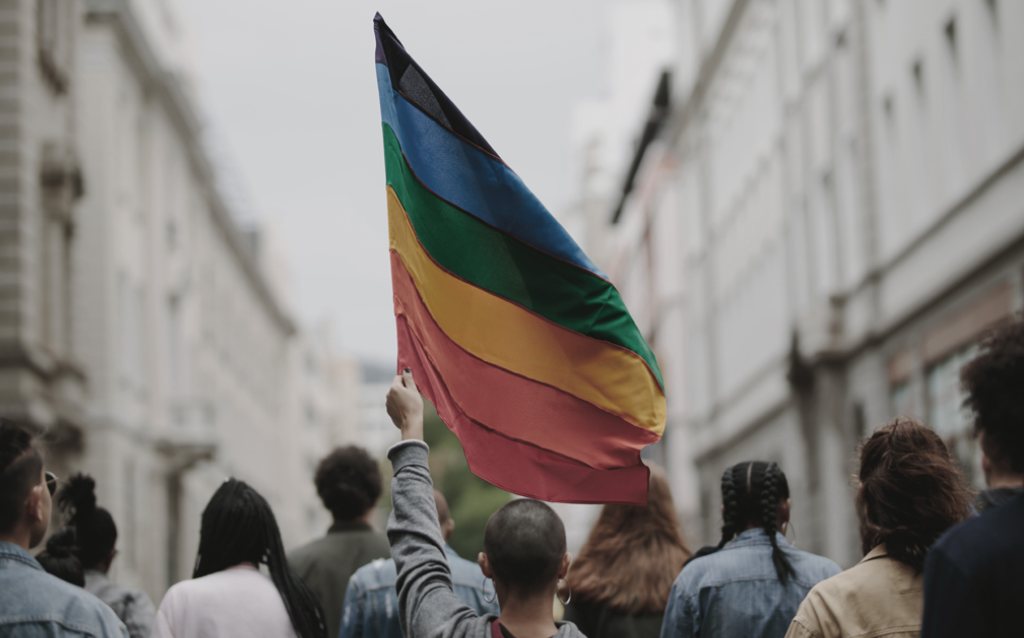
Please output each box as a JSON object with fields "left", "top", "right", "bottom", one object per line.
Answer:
{"left": 391, "top": 251, "right": 658, "bottom": 469}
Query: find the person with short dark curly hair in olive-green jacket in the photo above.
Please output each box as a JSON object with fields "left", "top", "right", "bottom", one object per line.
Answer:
{"left": 288, "top": 445, "right": 391, "bottom": 638}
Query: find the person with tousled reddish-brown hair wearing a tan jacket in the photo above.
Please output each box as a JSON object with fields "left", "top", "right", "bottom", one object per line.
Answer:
{"left": 786, "top": 417, "right": 973, "bottom": 638}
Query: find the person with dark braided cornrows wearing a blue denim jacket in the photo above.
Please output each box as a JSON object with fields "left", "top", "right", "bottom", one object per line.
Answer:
{"left": 662, "top": 461, "right": 840, "bottom": 638}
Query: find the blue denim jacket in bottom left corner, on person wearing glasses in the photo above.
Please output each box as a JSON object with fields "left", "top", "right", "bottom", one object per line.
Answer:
{"left": 0, "top": 543, "right": 128, "bottom": 638}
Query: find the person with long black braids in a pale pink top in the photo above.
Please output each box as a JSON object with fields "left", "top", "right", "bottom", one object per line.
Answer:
{"left": 153, "top": 478, "right": 327, "bottom": 638}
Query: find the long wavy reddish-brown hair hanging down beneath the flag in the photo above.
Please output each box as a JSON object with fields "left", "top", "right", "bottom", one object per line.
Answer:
{"left": 566, "top": 467, "right": 689, "bottom": 613}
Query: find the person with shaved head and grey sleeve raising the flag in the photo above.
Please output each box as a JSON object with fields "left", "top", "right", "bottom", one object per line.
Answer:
{"left": 387, "top": 370, "right": 584, "bottom": 638}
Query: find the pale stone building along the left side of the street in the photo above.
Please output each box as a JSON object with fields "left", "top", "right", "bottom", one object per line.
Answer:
{"left": 0, "top": 0, "right": 372, "bottom": 601}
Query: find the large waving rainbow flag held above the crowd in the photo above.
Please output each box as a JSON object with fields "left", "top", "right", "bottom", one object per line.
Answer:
{"left": 374, "top": 13, "right": 666, "bottom": 504}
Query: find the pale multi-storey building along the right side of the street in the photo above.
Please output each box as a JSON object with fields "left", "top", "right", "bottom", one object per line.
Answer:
{"left": 601, "top": 0, "right": 1024, "bottom": 565}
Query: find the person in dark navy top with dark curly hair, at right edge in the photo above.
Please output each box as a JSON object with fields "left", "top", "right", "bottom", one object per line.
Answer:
{"left": 921, "top": 315, "right": 1024, "bottom": 638}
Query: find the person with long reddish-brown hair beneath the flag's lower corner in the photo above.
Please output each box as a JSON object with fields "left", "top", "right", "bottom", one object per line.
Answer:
{"left": 562, "top": 466, "right": 690, "bottom": 638}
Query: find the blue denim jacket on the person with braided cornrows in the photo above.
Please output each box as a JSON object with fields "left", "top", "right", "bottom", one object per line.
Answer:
{"left": 662, "top": 529, "right": 841, "bottom": 638}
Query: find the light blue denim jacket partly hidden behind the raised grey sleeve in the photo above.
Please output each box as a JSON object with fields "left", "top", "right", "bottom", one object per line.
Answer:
{"left": 338, "top": 545, "right": 498, "bottom": 638}
